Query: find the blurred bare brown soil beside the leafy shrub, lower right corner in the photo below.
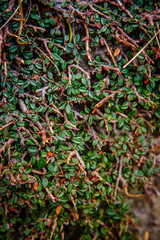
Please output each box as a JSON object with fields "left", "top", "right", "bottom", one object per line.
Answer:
{"left": 128, "top": 176, "right": 160, "bottom": 240}
